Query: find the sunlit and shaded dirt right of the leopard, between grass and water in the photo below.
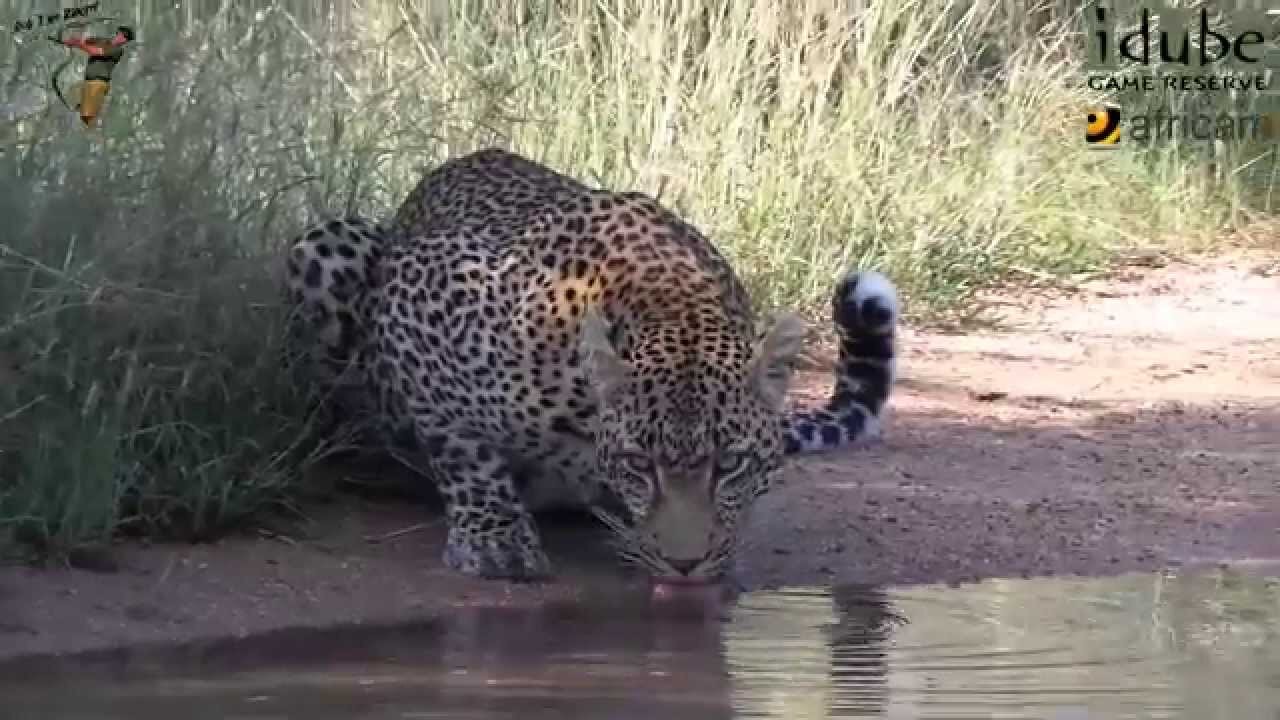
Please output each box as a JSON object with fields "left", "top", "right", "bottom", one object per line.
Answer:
{"left": 748, "top": 249, "right": 1280, "bottom": 583}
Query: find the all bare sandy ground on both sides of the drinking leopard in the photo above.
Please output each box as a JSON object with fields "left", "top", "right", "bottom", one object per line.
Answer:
{"left": 0, "top": 254, "right": 1280, "bottom": 656}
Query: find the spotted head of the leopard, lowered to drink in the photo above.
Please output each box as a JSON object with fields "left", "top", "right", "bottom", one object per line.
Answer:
{"left": 580, "top": 301, "right": 804, "bottom": 580}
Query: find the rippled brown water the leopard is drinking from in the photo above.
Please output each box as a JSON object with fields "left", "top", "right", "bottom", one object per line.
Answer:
{"left": 0, "top": 570, "right": 1280, "bottom": 720}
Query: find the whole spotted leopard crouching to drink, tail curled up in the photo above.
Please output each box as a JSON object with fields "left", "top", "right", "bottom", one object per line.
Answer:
{"left": 285, "top": 147, "right": 900, "bottom": 583}
